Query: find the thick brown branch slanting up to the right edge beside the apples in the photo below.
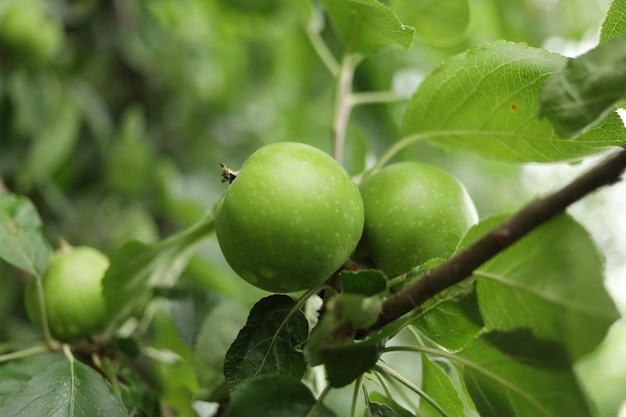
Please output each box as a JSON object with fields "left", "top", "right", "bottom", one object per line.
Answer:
{"left": 368, "top": 149, "right": 626, "bottom": 331}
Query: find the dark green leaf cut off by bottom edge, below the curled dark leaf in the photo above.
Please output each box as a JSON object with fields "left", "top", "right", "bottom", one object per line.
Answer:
{"left": 224, "top": 374, "right": 335, "bottom": 417}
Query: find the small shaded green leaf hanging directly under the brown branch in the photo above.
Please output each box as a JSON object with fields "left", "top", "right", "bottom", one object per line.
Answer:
{"left": 413, "top": 280, "right": 483, "bottom": 350}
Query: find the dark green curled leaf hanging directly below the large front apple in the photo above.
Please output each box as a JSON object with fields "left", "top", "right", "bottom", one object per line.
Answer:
{"left": 224, "top": 294, "right": 309, "bottom": 390}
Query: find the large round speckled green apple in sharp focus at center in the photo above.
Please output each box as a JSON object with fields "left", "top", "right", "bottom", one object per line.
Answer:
{"left": 215, "top": 142, "right": 364, "bottom": 292}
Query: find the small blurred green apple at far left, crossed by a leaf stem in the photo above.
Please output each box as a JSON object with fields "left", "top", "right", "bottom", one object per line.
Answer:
{"left": 26, "top": 246, "right": 109, "bottom": 342}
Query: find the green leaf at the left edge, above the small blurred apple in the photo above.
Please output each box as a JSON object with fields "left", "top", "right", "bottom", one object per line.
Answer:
{"left": 0, "top": 194, "right": 50, "bottom": 276}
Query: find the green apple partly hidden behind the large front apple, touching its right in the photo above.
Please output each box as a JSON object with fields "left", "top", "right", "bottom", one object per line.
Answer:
{"left": 359, "top": 162, "right": 478, "bottom": 278}
